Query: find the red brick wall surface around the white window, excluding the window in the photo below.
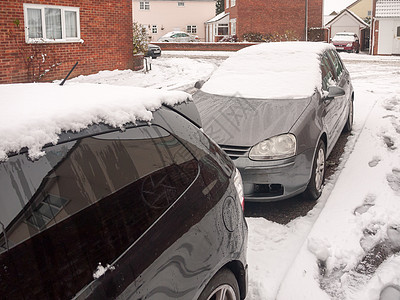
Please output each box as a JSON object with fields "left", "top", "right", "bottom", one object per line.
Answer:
{"left": 0, "top": 0, "right": 133, "bottom": 83}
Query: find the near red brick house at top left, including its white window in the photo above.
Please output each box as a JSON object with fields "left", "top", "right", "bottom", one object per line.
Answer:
{"left": 0, "top": 0, "right": 133, "bottom": 83}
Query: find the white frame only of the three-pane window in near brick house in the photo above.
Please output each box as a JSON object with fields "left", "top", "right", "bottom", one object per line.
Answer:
{"left": 23, "top": 3, "right": 82, "bottom": 44}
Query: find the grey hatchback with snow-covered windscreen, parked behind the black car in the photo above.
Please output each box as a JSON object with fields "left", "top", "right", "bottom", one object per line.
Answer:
{"left": 193, "top": 42, "right": 354, "bottom": 201}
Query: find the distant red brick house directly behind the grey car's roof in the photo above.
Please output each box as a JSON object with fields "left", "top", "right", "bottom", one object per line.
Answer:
{"left": 214, "top": 0, "right": 323, "bottom": 40}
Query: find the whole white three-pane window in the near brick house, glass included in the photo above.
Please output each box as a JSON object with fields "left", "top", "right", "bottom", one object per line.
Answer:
{"left": 24, "top": 4, "right": 80, "bottom": 43}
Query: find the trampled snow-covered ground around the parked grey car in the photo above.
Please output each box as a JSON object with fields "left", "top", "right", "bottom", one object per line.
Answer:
{"left": 66, "top": 52, "right": 400, "bottom": 300}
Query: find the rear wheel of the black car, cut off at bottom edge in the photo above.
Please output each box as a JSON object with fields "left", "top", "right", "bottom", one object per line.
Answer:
{"left": 199, "top": 268, "right": 240, "bottom": 300}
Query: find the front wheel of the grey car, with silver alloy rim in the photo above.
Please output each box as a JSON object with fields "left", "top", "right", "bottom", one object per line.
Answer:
{"left": 304, "top": 140, "right": 326, "bottom": 201}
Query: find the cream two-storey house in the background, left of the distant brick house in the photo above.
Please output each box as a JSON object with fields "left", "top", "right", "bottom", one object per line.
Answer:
{"left": 132, "top": 0, "right": 216, "bottom": 41}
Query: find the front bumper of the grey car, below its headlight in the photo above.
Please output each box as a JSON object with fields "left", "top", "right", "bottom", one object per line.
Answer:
{"left": 233, "top": 149, "right": 314, "bottom": 202}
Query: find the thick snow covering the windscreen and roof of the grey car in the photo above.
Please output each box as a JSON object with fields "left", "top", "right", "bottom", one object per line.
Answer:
{"left": 202, "top": 42, "right": 335, "bottom": 99}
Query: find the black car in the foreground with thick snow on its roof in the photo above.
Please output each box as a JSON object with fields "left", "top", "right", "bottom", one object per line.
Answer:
{"left": 0, "top": 84, "right": 247, "bottom": 300}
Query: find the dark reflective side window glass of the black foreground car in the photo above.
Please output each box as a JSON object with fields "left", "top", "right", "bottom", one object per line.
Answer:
{"left": 0, "top": 125, "right": 198, "bottom": 299}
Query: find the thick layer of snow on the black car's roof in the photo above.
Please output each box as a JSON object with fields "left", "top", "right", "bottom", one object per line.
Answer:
{"left": 0, "top": 83, "right": 190, "bottom": 161}
